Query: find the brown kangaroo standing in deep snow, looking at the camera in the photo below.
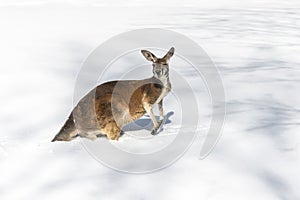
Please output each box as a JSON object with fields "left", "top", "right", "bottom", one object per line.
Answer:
{"left": 52, "top": 47, "right": 175, "bottom": 142}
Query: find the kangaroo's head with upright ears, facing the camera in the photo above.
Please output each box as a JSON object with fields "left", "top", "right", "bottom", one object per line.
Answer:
{"left": 142, "top": 47, "right": 175, "bottom": 79}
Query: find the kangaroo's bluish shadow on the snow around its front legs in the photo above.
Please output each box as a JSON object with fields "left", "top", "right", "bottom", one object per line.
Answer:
{"left": 122, "top": 111, "right": 174, "bottom": 132}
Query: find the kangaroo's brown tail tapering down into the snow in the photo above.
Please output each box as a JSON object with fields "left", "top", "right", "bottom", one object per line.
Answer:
{"left": 51, "top": 113, "right": 77, "bottom": 142}
